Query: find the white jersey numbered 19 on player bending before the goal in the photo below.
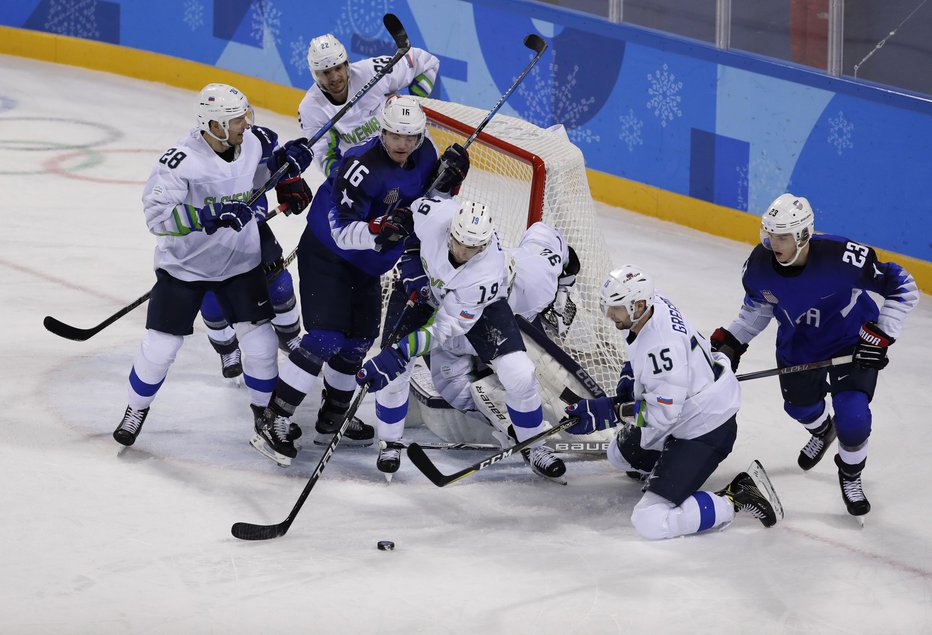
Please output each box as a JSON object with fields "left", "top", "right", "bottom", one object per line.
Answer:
{"left": 411, "top": 198, "right": 508, "bottom": 350}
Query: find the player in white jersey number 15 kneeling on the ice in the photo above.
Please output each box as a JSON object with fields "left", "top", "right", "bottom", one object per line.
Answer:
{"left": 566, "top": 265, "right": 783, "bottom": 539}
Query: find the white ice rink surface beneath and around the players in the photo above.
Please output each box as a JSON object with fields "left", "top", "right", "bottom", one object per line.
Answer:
{"left": 0, "top": 56, "right": 932, "bottom": 635}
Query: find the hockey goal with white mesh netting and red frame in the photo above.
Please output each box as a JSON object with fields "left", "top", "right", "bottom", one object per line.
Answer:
{"left": 419, "top": 99, "right": 624, "bottom": 394}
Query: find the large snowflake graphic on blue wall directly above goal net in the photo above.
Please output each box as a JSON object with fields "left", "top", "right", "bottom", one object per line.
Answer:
{"left": 513, "top": 51, "right": 600, "bottom": 144}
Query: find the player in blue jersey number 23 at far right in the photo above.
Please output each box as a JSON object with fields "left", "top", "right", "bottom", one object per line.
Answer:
{"left": 711, "top": 194, "right": 919, "bottom": 516}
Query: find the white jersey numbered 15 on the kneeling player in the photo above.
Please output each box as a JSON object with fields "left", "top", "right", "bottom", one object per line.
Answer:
{"left": 627, "top": 293, "right": 741, "bottom": 450}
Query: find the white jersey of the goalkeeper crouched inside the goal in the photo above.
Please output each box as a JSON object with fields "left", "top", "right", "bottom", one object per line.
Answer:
{"left": 505, "top": 222, "right": 570, "bottom": 322}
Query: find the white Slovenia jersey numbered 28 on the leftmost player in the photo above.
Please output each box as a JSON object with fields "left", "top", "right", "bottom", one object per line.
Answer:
{"left": 142, "top": 128, "right": 270, "bottom": 282}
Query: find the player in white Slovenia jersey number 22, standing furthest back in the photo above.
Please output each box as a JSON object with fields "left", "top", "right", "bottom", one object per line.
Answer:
{"left": 298, "top": 33, "right": 440, "bottom": 177}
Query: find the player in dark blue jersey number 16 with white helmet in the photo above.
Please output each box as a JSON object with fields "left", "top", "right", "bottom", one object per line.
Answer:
{"left": 252, "top": 96, "right": 468, "bottom": 466}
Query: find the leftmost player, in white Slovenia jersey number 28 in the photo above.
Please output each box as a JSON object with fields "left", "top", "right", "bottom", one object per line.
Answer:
{"left": 113, "top": 84, "right": 311, "bottom": 445}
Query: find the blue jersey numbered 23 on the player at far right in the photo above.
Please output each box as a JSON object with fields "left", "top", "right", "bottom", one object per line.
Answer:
{"left": 728, "top": 234, "right": 919, "bottom": 365}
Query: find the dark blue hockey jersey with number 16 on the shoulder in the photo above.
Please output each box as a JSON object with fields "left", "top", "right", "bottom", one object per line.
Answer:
{"left": 307, "top": 137, "right": 437, "bottom": 276}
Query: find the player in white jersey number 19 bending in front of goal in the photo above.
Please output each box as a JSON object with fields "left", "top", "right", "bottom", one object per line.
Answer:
{"left": 357, "top": 198, "right": 566, "bottom": 479}
